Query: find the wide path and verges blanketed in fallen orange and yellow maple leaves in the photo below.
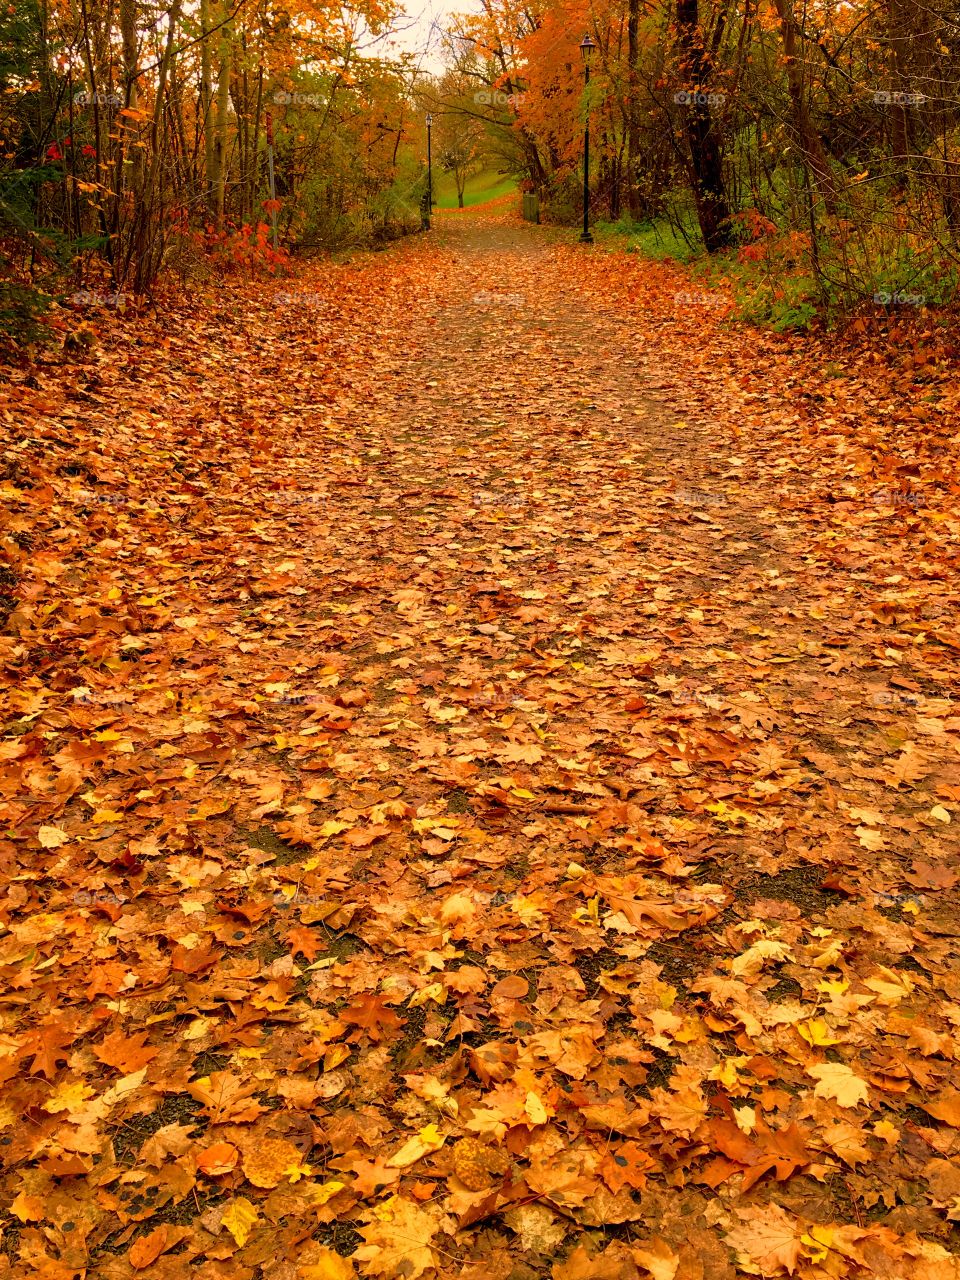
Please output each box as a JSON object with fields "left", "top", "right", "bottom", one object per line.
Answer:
{"left": 0, "top": 209, "right": 960, "bottom": 1280}
